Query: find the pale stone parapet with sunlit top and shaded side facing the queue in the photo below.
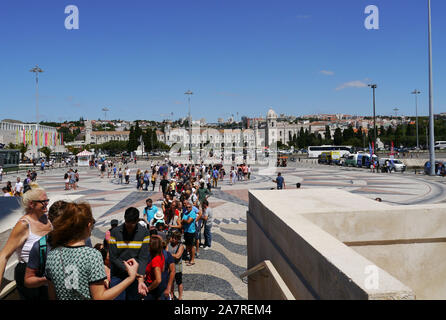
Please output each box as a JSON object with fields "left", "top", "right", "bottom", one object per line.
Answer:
{"left": 248, "top": 189, "right": 415, "bottom": 299}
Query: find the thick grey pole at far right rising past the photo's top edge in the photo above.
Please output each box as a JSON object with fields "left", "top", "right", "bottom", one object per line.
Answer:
{"left": 427, "top": 0, "right": 435, "bottom": 176}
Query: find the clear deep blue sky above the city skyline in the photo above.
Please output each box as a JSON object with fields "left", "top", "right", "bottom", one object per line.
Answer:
{"left": 0, "top": 0, "right": 446, "bottom": 122}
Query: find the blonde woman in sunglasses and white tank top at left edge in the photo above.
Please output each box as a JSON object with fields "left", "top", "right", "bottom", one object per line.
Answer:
{"left": 0, "top": 184, "right": 52, "bottom": 300}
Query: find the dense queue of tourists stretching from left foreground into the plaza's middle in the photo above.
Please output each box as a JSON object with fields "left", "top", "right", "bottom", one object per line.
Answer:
{"left": 0, "top": 163, "right": 214, "bottom": 300}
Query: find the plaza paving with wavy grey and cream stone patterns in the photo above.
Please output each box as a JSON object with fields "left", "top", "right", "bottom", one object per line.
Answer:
{"left": 0, "top": 162, "right": 446, "bottom": 300}
